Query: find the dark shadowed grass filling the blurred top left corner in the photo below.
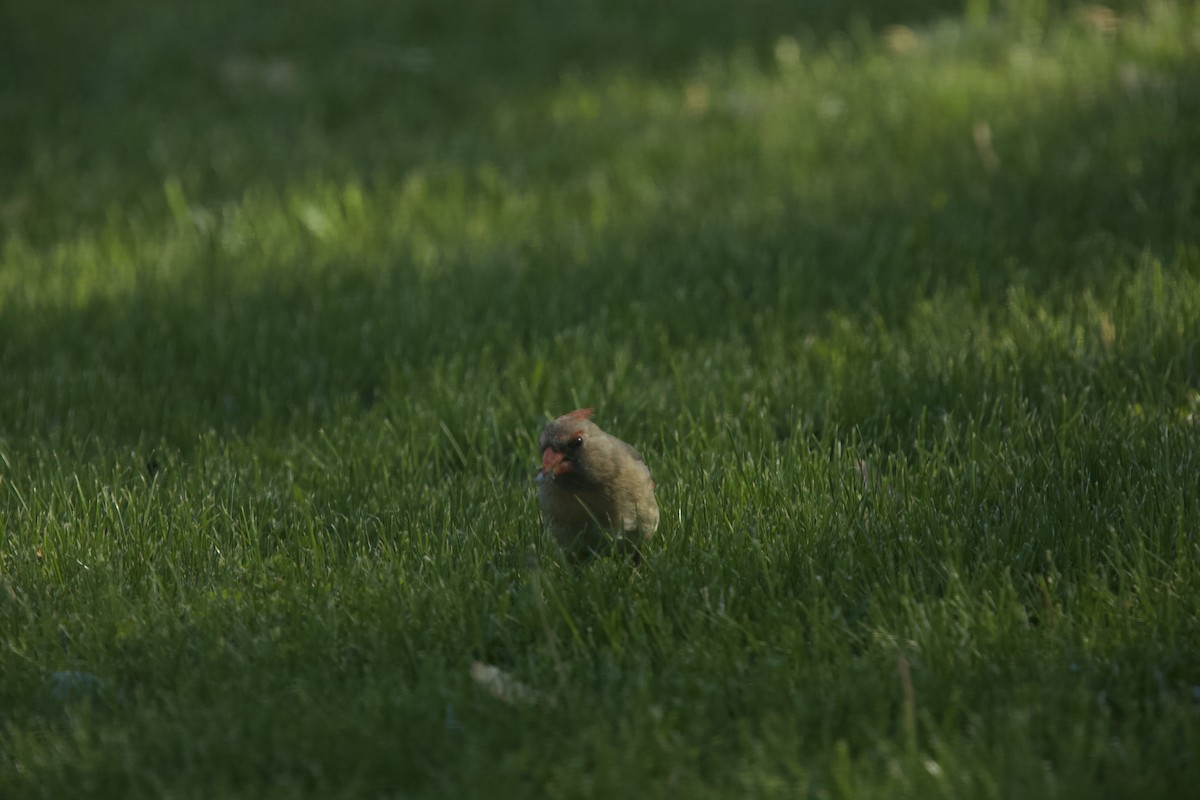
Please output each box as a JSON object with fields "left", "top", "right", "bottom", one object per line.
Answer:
{"left": 7, "top": 0, "right": 961, "bottom": 243}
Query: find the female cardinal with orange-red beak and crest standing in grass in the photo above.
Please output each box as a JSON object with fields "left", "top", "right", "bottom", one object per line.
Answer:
{"left": 536, "top": 408, "right": 659, "bottom": 564}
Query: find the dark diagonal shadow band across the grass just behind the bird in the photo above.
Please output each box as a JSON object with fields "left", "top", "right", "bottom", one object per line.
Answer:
{"left": 0, "top": 4, "right": 1200, "bottom": 449}
